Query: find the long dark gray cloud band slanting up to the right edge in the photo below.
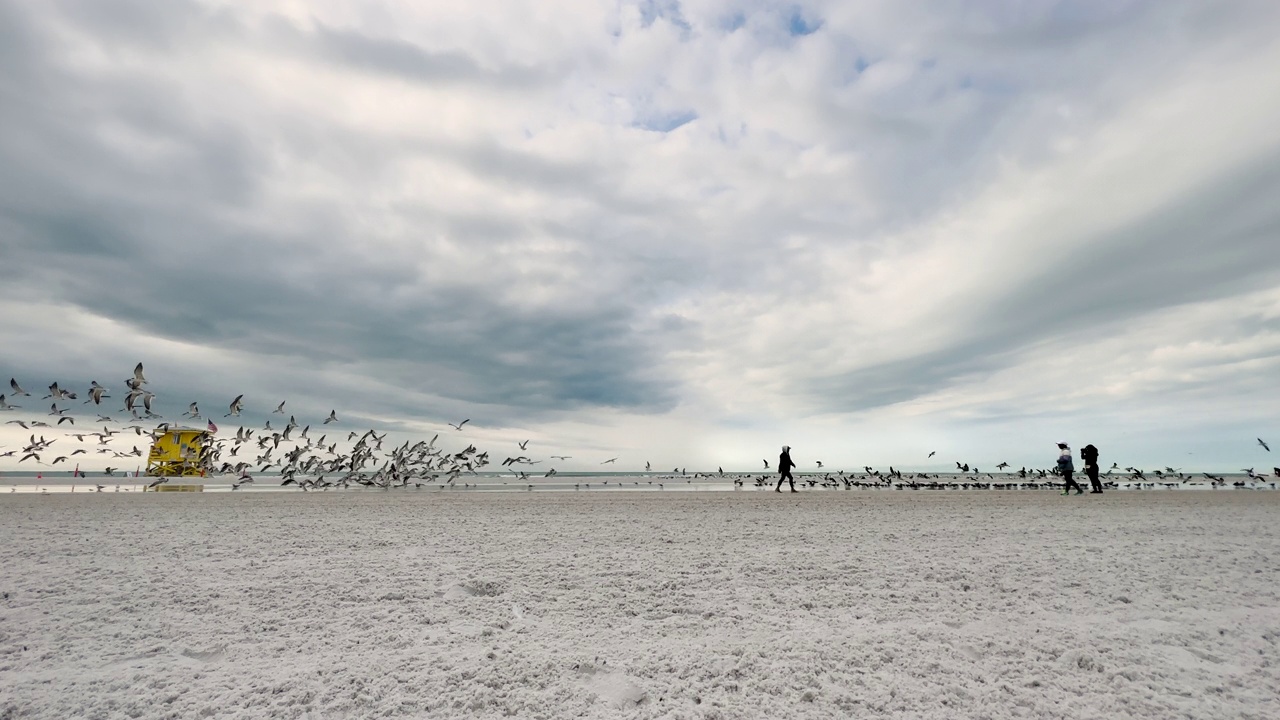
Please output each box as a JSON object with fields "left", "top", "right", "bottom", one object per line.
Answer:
{"left": 809, "top": 148, "right": 1280, "bottom": 410}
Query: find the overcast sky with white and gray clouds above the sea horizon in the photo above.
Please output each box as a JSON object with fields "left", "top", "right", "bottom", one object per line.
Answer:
{"left": 0, "top": 0, "right": 1280, "bottom": 470}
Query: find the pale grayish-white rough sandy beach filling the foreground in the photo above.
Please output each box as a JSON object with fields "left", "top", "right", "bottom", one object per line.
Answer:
{"left": 0, "top": 491, "right": 1280, "bottom": 719}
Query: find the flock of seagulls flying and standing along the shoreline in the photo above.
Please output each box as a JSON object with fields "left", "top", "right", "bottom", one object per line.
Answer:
{"left": 0, "top": 363, "right": 1280, "bottom": 491}
